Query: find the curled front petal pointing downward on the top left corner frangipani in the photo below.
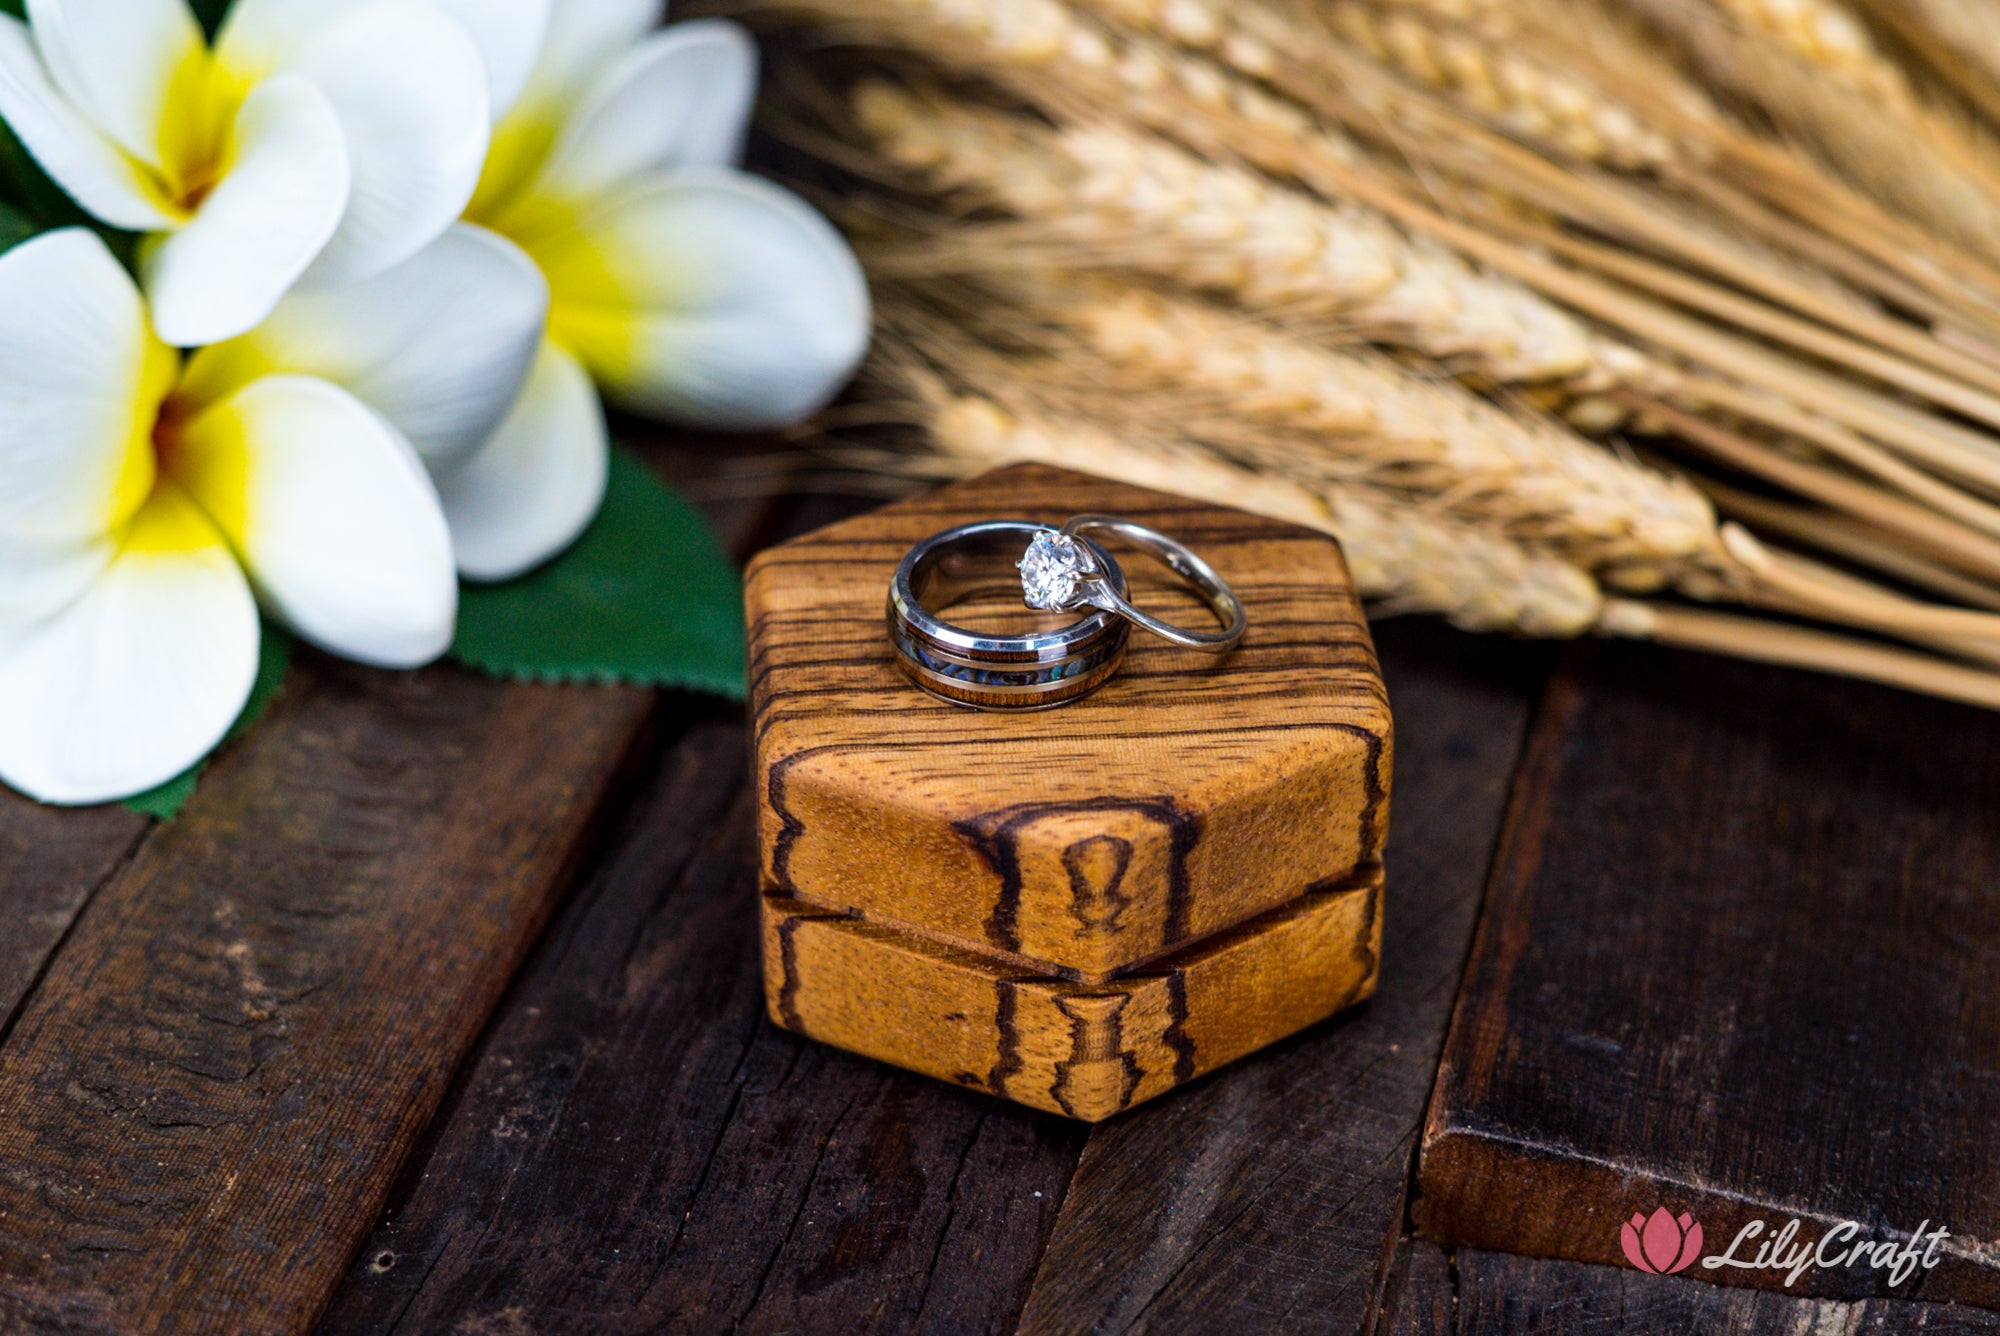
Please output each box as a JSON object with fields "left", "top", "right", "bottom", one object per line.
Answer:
{"left": 142, "top": 74, "right": 348, "bottom": 348}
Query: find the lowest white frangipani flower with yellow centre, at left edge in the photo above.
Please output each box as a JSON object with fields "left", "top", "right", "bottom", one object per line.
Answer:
{"left": 0, "top": 228, "right": 548, "bottom": 802}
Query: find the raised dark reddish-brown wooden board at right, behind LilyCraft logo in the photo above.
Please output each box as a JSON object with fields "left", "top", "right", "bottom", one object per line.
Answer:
{"left": 1414, "top": 646, "right": 2000, "bottom": 1306}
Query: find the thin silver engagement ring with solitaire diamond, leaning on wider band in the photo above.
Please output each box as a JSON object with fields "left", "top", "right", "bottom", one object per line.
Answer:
{"left": 1020, "top": 514, "right": 1250, "bottom": 654}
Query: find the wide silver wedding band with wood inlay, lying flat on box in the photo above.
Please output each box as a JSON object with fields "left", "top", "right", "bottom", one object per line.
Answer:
{"left": 888, "top": 520, "right": 1130, "bottom": 710}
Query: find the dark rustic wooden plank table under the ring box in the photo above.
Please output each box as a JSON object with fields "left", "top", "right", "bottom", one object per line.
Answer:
{"left": 0, "top": 446, "right": 2000, "bottom": 1336}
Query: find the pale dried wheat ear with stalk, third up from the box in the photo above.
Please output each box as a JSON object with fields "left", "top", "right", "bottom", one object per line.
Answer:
{"left": 854, "top": 80, "right": 2000, "bottom": 532}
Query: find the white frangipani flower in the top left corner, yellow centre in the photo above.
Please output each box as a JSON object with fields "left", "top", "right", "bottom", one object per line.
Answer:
{"left": 0, "top": 0, "right": 546, "bottom": 348}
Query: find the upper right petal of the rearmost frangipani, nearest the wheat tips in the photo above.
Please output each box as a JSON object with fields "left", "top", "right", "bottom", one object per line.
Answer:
{"left": 542, "top": 18, "right": 756, "bottom": 198}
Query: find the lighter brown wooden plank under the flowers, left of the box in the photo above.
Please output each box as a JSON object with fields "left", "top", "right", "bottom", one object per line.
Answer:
{"left": 0, "top": 656, "right": 650, "bottom": 1332}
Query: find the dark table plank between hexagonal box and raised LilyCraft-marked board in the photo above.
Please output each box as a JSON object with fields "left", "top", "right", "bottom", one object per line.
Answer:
{"left": 1022, "top": 622, "right": 1546, "bottom": 1332}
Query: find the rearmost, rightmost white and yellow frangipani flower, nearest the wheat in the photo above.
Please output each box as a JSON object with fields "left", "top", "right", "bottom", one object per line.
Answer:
{"left": 466, "top": 0, "right": 870, "bottom": 460}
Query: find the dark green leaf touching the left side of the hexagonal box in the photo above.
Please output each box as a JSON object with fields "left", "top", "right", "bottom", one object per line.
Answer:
{"left": 452, "top": 450, "right": 744, "bottom": 700}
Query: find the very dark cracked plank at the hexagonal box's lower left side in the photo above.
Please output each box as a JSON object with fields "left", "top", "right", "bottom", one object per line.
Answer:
{"left": 324, "top": 714, "right": 1082, "bottom": 1332}
